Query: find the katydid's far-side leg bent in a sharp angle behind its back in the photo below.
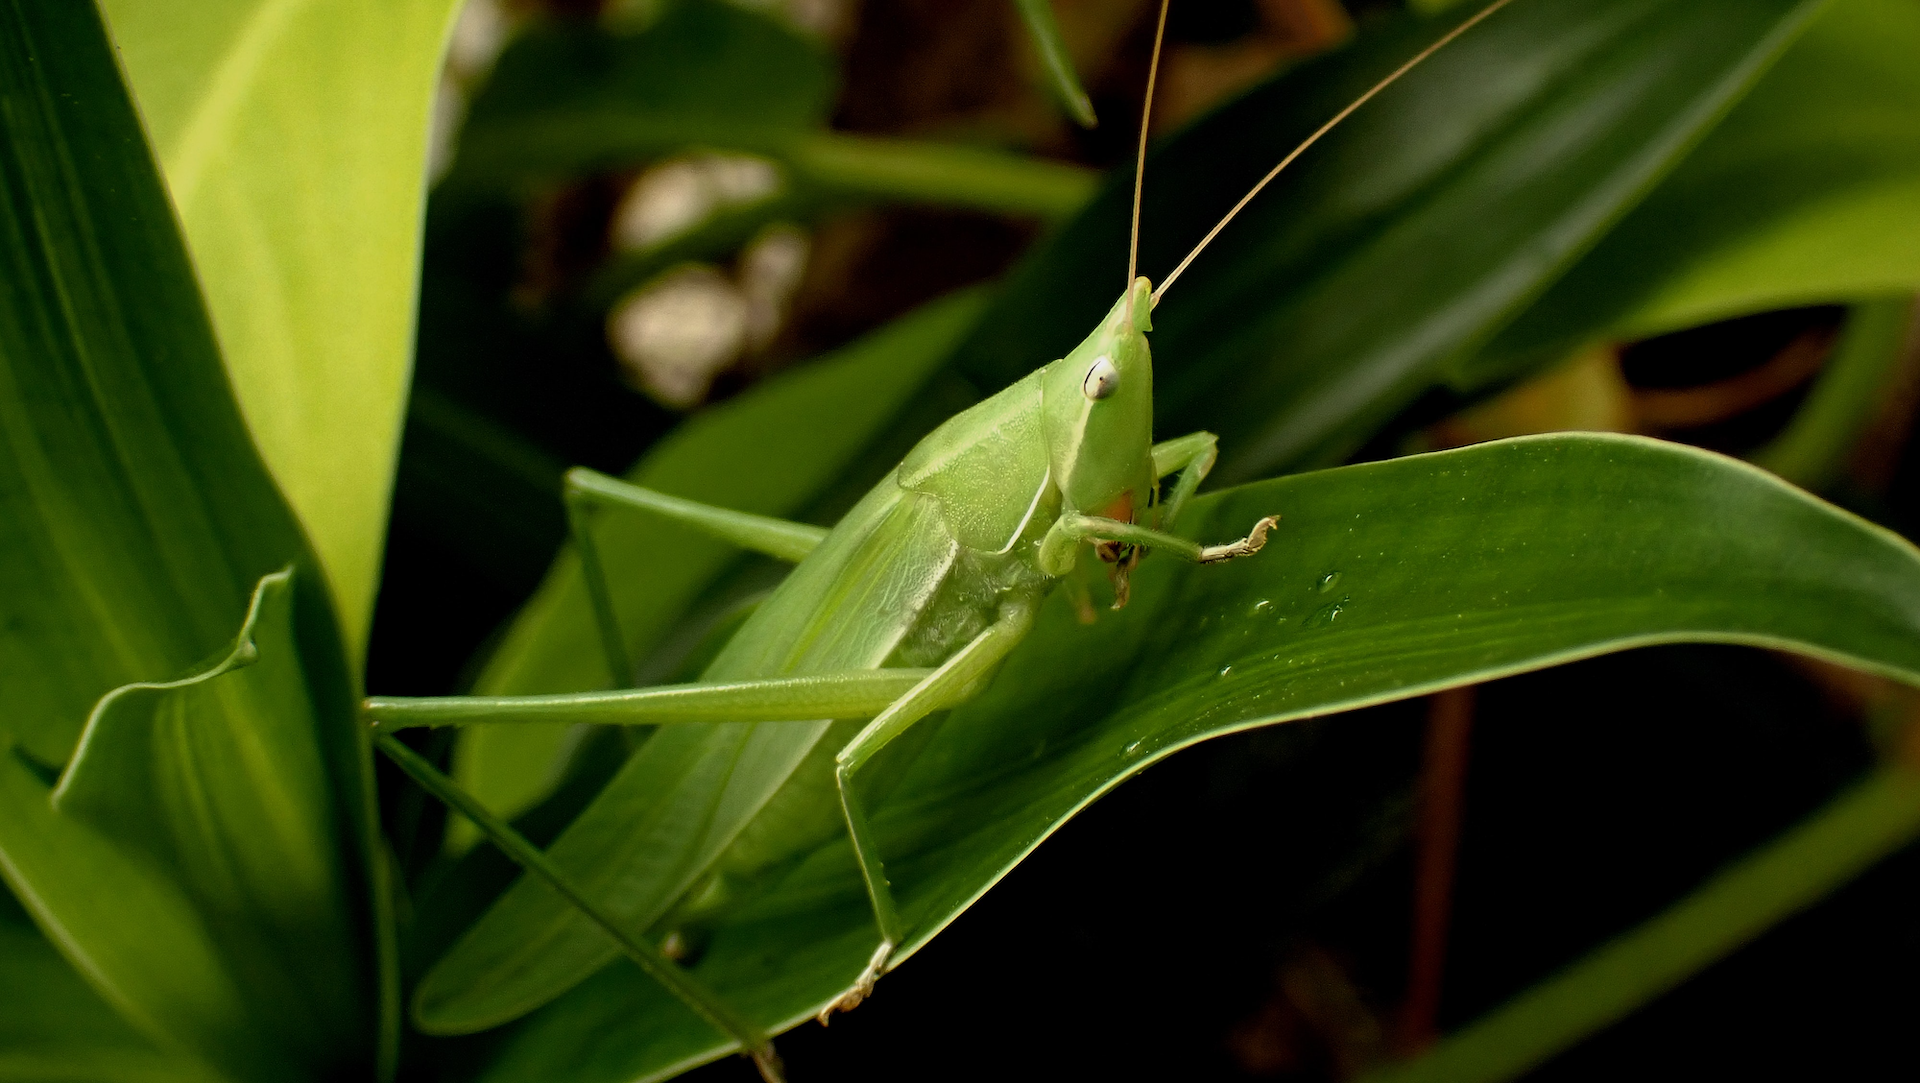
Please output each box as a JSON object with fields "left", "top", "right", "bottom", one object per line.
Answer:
{"left": 563, "top": 467, "right": 828, "bottom": 687}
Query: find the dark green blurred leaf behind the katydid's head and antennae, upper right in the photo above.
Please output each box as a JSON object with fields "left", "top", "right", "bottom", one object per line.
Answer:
{"left": 956, "top": 0, "right": 1818, "bottom": 482}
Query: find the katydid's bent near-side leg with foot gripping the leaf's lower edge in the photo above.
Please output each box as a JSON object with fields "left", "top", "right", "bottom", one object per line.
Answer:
{"left": 818, "top": 609, "right": 1033, "bottom": 1023}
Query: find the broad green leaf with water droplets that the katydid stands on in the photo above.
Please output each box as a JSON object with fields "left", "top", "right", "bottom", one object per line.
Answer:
{"left": 464, "top": 436, "right": 1920, "bottom": 1083}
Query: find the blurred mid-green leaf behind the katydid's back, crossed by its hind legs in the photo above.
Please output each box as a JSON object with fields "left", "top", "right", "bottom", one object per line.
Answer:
{"left": 455, "top": 294, "right": 983, "bottom": 843}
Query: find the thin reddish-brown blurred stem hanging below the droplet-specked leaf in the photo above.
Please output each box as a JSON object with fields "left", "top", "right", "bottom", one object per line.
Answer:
{"left": 1394, "top": 686, "right": 1473, "bottom": 1056}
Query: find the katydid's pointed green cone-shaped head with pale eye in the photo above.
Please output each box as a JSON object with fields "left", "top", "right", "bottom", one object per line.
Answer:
{"left": 1041, "top": 278, "right": 1154, "bottom": 522}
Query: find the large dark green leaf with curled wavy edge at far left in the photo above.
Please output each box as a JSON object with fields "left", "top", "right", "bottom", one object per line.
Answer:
{"left": 0, "top": 0, "right": 382, "bottom": 1079}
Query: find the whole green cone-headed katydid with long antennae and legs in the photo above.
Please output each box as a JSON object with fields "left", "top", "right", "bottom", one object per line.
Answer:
{"left": 367, "top": 0, "right": 1511, "bottom": 1079}
